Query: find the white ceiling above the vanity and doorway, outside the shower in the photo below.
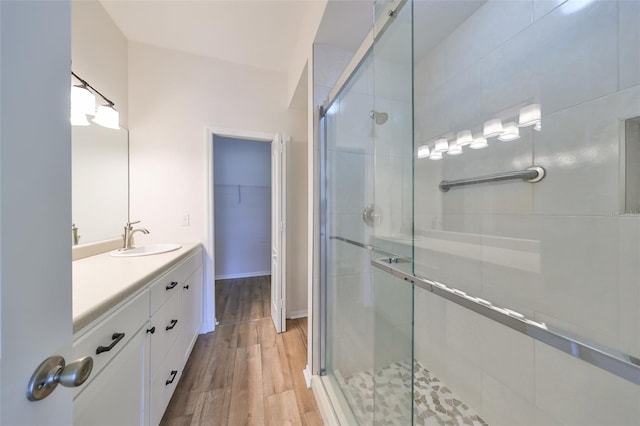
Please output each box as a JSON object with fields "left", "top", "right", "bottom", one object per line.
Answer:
{"left": 101, "top": 0, "right": 318, "bottom": 72}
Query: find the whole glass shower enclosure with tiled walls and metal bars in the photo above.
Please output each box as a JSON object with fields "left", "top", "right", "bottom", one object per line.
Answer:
{"left": 320, "top": 0, "right": 640, "bottom": 425}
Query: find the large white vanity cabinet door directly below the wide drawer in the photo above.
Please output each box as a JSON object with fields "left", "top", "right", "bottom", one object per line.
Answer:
{"left": 73, "top": 327, "right": 148, "bottom": 426}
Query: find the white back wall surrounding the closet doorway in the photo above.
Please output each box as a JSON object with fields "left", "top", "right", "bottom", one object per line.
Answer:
{"left": 129, "top": 42, "right": 307, "bottom": 327}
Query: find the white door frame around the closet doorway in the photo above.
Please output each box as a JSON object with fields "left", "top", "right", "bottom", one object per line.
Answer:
{"left": 204, "top": 127, "right": 287, "bottom": 331}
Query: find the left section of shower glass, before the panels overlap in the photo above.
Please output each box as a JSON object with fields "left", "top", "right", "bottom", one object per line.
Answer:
{"left": 324, "top": 58, "right": 374, "bottom": 424}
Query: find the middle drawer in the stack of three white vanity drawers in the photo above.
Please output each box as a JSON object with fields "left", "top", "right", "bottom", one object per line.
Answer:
{"left": 149, "top": 287, "right": 182, "bottom": 377}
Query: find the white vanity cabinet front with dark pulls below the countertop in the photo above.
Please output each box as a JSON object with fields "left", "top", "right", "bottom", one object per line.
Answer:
{"left": 73, "top": 248, "right": 203, "bottom": 426}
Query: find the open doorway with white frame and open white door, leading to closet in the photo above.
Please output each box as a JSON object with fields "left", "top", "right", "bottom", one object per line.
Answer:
{"left": 208, "top": 130, "right": 287, "bottom": 333}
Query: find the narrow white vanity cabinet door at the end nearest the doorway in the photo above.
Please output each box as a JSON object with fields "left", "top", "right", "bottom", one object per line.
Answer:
{"left": 181, "top": 266, "right": 203, "bottom": 363}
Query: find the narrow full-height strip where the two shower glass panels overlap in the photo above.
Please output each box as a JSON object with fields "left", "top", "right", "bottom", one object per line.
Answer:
{"left": 371, "top": 2, "right": 414, "bottom": 425}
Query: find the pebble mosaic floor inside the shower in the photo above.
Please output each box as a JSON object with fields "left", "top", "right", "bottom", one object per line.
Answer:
{"left": 336, "top": 361, "right": 487, "bottom": 426}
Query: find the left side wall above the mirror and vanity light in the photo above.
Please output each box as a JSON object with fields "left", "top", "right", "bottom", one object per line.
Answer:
{"left": 71, "top": 0, "right": 129, "bottom": 126}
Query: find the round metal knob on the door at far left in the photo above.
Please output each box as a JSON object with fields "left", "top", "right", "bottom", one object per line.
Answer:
{"left": 27, "top": 355, "right": 93, "bottom": 401}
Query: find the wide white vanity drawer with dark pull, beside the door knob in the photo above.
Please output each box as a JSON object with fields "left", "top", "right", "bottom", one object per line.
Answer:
{"left": 73, "top": 290, "right": 149, "bottom": 393}
